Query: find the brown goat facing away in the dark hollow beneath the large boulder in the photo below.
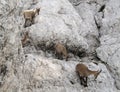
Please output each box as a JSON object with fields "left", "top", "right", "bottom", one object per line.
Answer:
{"left": 55, "top": 43, "right": 68, "bottom": 61}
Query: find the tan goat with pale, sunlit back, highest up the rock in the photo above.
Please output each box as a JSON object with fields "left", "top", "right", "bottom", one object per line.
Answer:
{"left": 23, "top": 8, "right": 40, "bottom": 27}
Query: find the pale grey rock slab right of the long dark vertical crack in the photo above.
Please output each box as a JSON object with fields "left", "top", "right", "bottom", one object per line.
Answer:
{"left": 96, "top": 0, "right": 120, "bottom": 89}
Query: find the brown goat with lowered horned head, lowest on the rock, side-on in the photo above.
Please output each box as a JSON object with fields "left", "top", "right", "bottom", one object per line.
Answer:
{"left": 76, "top": 64, "right": 101, "bottom": 87}
